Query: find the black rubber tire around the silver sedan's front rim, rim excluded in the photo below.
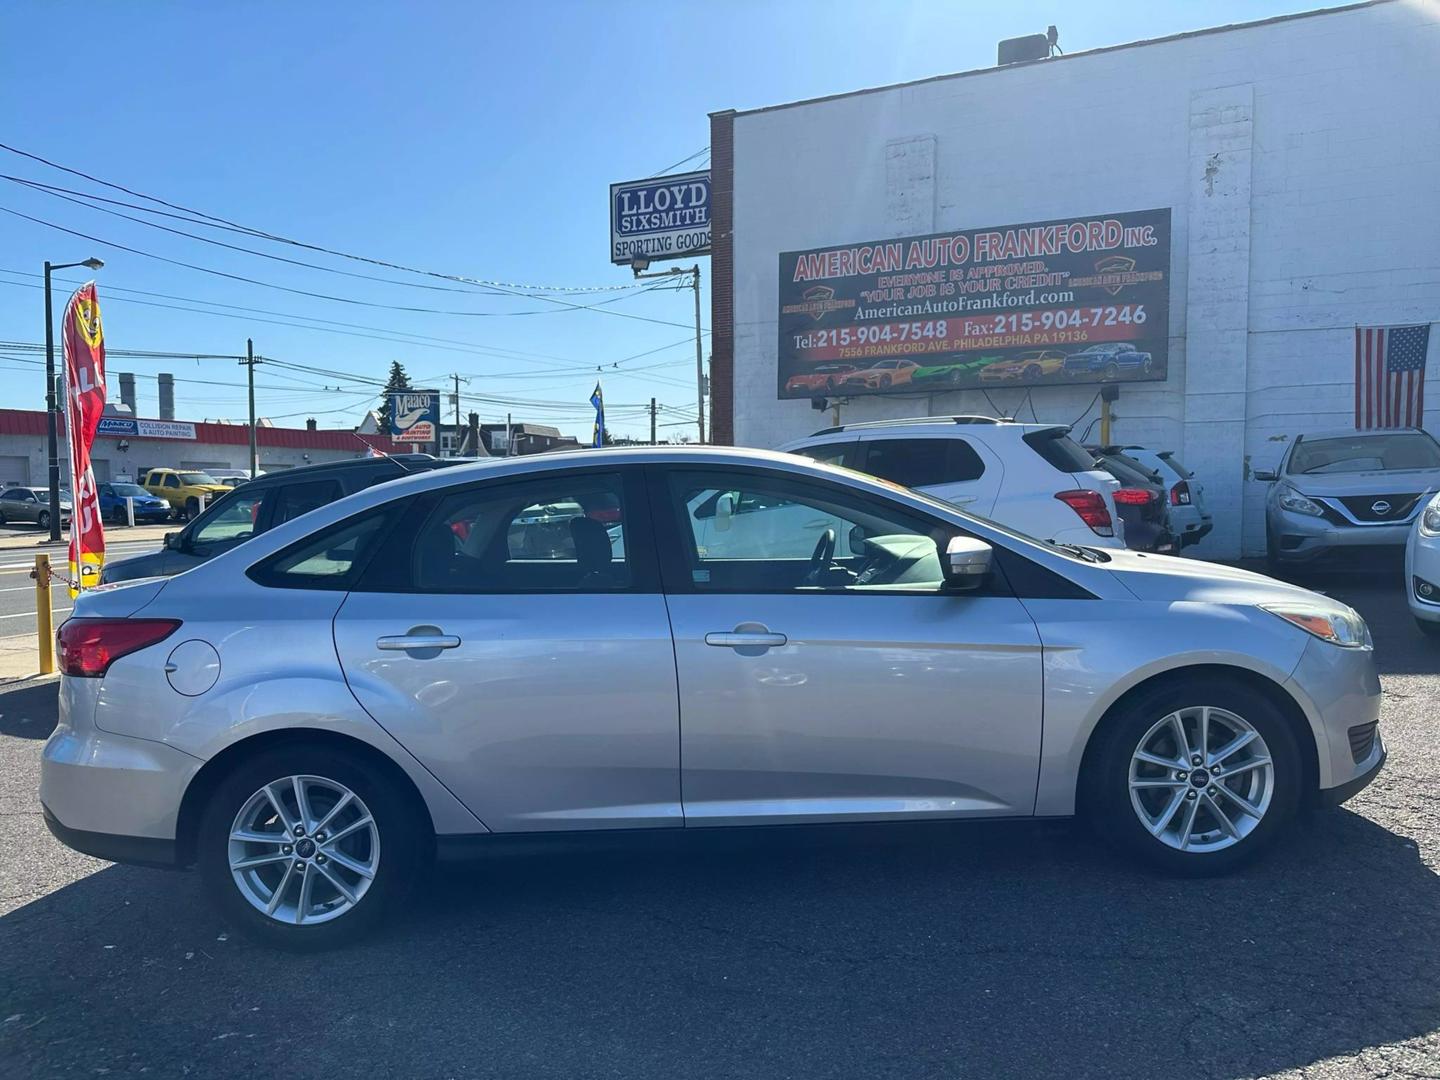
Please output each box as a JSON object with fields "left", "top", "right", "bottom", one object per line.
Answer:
{"left": 1080, "top": 677, "right": 1305, "bottom": 877}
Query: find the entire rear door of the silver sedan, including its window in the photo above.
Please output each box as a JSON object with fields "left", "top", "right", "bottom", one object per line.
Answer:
{"left": 336, "top": 469, "right": 684, "bottom": 832}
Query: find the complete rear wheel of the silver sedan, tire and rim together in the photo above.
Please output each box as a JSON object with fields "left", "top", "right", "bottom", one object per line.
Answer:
{"left": 197, "top": 743, "right": 425, "bottom": 950}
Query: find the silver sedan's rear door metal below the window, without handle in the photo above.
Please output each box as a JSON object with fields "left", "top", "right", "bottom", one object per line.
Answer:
{"left": 336, "top": 592, "right": 684, "bottom": 832}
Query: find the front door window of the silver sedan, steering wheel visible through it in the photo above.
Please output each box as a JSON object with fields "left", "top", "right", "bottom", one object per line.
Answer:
{"left": 668, "top": 471, "right": 946, "bottom": 592}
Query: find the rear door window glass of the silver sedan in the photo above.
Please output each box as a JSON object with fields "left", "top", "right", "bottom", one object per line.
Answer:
{"left": 377, "top": 474, "right": 635, "bottom": 593}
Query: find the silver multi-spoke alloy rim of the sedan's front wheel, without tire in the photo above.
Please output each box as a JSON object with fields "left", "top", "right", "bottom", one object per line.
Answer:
{"left": 1129, "top": 706, "right": 1274, "bottom": 852}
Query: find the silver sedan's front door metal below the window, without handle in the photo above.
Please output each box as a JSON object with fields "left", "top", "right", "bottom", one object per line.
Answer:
{"left": 670, "top": 593, "right": 1041, "bottom": 825}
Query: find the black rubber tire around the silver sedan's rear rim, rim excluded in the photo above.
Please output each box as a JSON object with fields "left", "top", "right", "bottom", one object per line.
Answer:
{"left": 196, "top": 742, "right": 429, "bottom": 952}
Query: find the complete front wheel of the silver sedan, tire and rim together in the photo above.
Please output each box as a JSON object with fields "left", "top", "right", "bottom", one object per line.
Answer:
{"left": 1081, "top": 680, "right": 1303, "bottom": 876}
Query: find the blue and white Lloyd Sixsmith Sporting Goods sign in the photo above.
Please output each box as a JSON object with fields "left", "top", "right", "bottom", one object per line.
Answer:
{"left": 611, "top": 173, "right": 710, "bottom": 266}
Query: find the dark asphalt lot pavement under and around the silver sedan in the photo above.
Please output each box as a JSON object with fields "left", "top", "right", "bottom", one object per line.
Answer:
{"left": 0, "top": 577, "right": 1440, "bottom": 1080}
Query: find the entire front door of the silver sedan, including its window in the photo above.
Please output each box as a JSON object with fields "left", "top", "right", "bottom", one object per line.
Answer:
{"left": 654, "top": 468, "right": 1043, "bottom": 825}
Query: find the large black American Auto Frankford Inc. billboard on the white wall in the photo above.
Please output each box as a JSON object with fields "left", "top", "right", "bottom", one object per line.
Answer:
{"left": 778, "top": 209, "right": 1171, "bottom": 397}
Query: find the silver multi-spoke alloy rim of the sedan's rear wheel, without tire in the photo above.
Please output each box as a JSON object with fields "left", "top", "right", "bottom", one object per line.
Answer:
{"left": 229, "top": 776, "right": 380, "bottom": 926}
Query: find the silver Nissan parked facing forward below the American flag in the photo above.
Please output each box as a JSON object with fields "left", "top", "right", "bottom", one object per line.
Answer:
{"left": 1254, "top": 428, "right": 1440, "bottom": 570}
